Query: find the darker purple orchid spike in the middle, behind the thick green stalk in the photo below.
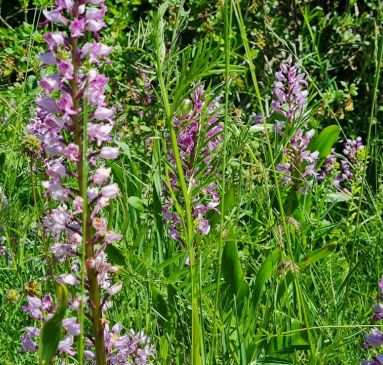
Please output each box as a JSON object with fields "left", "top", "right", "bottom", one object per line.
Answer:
{"left": 162, "top": 86, "right": 223, "bottom": 240}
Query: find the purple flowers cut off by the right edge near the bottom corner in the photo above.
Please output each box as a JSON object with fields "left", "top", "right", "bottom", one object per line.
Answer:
{"left": 361, "top": 279, "right": 383, "bottom": 365}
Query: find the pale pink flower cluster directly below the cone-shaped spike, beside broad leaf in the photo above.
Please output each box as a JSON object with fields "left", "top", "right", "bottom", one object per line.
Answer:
{"left": 277, "top": 129, "right": 319, "bottom": 194}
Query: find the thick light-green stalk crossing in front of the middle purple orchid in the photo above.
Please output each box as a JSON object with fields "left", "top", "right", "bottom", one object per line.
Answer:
{"left": 156, "top": 27, "right": 201, "bottom": 365}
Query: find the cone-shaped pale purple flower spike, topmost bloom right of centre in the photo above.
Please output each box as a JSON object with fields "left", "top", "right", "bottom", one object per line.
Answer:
{"left": 271, "top": 55, "right": 307, "bottom": 123}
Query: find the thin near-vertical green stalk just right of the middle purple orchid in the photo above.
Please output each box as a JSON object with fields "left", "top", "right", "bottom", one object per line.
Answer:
{"left": 209, "top": 0, "right": 232, "bottom": 364}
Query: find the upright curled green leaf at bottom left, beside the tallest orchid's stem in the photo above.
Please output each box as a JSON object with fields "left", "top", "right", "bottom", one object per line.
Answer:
{"left": 39, "top": 284, "right": 68, "bottom": 365}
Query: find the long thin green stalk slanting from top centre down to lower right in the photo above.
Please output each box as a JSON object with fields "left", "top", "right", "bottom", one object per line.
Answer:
{"left": 233, "top": 0, "right": 316, "bottom": 362}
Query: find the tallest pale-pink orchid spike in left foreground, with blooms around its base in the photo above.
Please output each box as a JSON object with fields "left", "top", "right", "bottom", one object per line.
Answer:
{"left": 23, "top": 0, "right": 155, "bottom": 365}
